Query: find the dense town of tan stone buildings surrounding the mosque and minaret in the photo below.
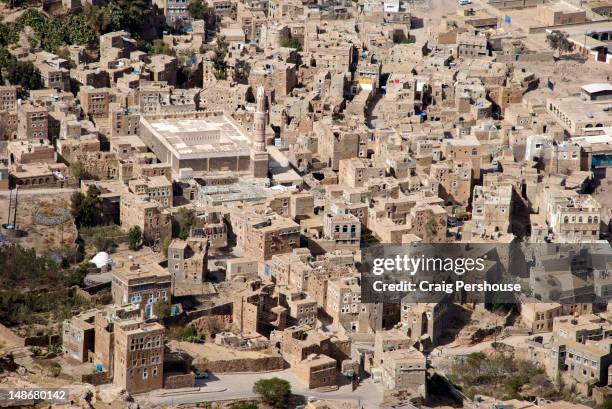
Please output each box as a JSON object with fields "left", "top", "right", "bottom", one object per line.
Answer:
{"left": 0, "top": 0, "right": 612, "bottom": 400}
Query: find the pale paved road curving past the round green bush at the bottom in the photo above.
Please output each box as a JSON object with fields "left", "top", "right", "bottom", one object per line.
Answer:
{"left": 136, "top": 370, "right": 382, "bottom": 409}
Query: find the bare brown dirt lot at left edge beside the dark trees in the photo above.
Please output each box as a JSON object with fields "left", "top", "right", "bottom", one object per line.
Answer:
{"left": 0, "top": 190, "right": 77, "bottom": 251}
